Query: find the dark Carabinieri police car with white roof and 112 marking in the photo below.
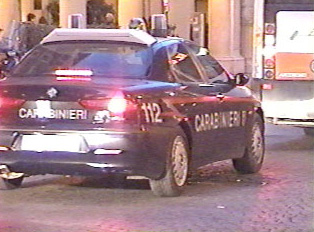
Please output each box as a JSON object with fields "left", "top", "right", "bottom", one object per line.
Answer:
{"left": 0, "top": 21, "right": 264, "bottom": 196}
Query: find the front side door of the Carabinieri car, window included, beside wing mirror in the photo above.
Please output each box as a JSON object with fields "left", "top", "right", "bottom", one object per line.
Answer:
{"left": 193, "top": 44, "right": 254, "bottom": 160}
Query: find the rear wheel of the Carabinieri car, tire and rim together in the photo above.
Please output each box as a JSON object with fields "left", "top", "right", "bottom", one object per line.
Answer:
{"left": 149, "top": 131, "right": 189, "bottom": 197}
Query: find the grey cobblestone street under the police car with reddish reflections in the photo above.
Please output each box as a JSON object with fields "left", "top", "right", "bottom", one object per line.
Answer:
{"left": 0, "top": 125, "right": 314, "bottom": 232}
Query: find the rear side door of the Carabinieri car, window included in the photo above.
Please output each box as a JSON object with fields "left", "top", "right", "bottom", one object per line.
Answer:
{"left": 168, "top": 42, "right": 221, "bottom": 167}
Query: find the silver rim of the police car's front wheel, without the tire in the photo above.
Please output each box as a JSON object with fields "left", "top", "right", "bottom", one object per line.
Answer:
{"left": 252, "top": 124, "right": 264, "bottom": 163}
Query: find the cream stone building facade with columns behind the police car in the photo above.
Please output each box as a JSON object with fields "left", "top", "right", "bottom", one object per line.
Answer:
{"left": 0, "top": 0, "right": 264, "bottom": 74}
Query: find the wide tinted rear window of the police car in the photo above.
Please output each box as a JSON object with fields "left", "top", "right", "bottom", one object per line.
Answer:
{"left": 12, "top": 41, "right": 152, "bottom": 78}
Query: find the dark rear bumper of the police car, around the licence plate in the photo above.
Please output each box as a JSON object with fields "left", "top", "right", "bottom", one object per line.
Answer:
{"left": 0, "top": 129, "right": 169, "bottom": 179}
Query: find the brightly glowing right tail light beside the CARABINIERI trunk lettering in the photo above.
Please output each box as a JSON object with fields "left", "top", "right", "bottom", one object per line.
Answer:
{"left": 79, "top": 92, "right": 137, "bottom": 121}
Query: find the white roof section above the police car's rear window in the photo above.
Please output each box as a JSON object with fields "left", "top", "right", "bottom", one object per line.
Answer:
{"left": 41, "top": 28, "right": 157, "bottom": 46}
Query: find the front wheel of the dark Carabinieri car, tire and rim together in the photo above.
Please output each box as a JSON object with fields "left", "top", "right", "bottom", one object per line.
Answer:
{"left": 232, "top": 114, "right": 265, "bottom": 174}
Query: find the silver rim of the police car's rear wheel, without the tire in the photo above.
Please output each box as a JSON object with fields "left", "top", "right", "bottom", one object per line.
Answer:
{"left": 171, "top": 136, "right": 188, "bottom": 186}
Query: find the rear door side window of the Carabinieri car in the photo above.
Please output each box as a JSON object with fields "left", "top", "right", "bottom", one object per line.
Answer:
{"left": 168, "top": 43, "right": 203, "bottom": 83}
